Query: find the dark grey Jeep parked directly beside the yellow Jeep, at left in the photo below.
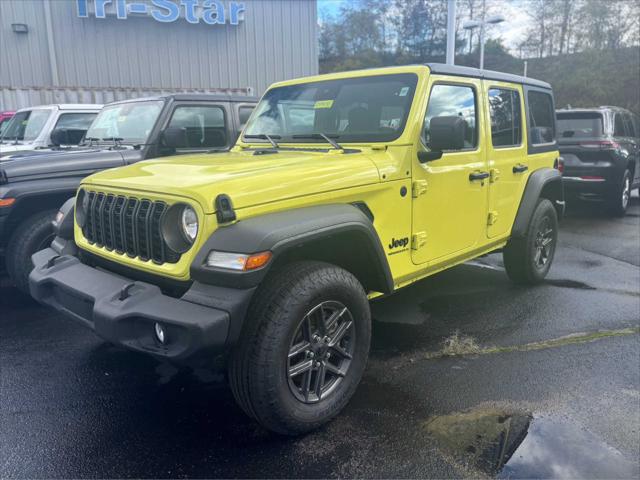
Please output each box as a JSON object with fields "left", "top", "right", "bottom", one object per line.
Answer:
{"left": 0, "top": 95, "right": 257, "bottom": 291}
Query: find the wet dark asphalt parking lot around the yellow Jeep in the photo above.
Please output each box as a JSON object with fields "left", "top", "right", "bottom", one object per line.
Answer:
{"left": 0, "top": 196, "right": 640, "bottom": 478}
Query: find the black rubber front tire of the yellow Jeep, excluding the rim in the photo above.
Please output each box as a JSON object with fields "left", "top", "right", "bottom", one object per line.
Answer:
{"left": 229, "top": 261, "right": 371, "bottom": 435}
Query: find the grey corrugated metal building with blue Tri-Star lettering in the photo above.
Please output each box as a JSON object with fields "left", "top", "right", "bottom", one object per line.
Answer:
{"left": 0, "top": 0, "right": 318, "bottom": 110}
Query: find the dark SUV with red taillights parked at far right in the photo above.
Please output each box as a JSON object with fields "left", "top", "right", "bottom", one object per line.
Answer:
{"left": 556, "top": 107, "right": 640, "bottom": 216}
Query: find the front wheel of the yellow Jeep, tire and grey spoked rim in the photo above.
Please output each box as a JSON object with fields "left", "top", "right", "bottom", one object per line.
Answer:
{"left": 229, "top": 262, "right": 371, "bottom": 435}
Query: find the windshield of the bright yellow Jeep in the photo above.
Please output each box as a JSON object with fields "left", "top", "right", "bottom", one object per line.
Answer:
{"left": 244, "top": 73, "right": 418, "bottom": 143}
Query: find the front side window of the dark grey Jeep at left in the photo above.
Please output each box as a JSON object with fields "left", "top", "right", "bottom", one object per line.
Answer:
{"left": 169, "top": 105, "right": 227, "bottom": 148}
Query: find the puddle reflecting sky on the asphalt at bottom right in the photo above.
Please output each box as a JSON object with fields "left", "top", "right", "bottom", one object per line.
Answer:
{"left": 424, "top": 409, "right": 640, "bottom": 478}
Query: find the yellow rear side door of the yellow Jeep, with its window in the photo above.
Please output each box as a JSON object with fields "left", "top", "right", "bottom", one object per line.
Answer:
{"left": 484, "top": 81, "right": 529, "bottom": 238}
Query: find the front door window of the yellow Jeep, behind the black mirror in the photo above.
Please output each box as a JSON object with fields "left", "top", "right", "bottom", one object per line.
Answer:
{"left": 422, "top": 85, "right": 478, "bottom": 148}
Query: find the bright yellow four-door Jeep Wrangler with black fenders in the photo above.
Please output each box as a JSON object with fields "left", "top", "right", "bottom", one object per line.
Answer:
{"left": 30, "top": 64, "right": 564, "bottom": 434}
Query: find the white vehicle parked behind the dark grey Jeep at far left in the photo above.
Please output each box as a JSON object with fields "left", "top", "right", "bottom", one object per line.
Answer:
{"left": 0, "top": 104, "right": 102, "bottom": 157}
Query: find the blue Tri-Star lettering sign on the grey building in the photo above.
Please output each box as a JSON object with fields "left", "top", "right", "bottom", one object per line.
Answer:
{"left": 76, "top": 0, "right": 245, "bottom": 25}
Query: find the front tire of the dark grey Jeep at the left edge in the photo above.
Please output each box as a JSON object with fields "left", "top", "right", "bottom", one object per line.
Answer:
{"left": 5, "top": 210, "right": 57, "bottom": 294}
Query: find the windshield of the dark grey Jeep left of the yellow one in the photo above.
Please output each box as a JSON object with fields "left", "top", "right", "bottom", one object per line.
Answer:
{"left": 85, "top": 101, "right": 163, "bottom": 143}
